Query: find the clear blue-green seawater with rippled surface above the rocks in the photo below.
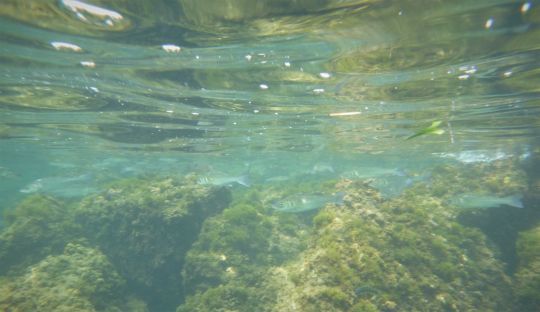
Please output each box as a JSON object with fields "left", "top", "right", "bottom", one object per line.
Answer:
{"left": 0, "top": 0, "right": 540, "bottom": 311}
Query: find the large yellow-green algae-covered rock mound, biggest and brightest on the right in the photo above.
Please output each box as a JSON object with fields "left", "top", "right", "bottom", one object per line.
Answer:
{"left": 273, "top": 184, "right": 512, "bottom": 311}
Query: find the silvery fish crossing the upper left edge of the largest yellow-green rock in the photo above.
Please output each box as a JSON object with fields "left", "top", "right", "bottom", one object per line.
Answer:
{"left": 272, "top": 193, "right": 343, "bottom": 213}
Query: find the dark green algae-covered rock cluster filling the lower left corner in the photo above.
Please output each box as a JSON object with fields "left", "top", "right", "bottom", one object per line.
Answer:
{"left": 0, "top": 177, "right": 231, "bottom": 311}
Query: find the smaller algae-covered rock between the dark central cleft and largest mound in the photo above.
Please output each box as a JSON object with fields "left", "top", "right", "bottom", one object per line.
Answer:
{"left": 177, "top": 194, "right": 307, "bottom": 312}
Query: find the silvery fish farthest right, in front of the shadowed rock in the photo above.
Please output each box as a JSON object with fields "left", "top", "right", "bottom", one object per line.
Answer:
{"left": 451, "top": 193, "right": 523, "bottom": 209}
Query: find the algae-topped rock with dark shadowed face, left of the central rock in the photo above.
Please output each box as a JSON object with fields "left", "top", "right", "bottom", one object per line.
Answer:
{"left": 75, "top": 179, "right": 230, "bottom": 310}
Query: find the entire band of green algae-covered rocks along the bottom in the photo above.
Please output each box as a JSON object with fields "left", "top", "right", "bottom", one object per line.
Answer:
{"left": 0, "top": 160, "right": 540, "bottom": 312}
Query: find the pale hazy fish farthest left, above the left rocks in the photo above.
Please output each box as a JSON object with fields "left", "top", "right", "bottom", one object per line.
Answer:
{"left": 19, "top": 174, "right": 99, "bottom": 198}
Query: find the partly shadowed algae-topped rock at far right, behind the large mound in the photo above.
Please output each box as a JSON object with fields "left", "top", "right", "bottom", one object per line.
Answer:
{"left": 416, "top": 160, "right": 528, "bottom": 272}
